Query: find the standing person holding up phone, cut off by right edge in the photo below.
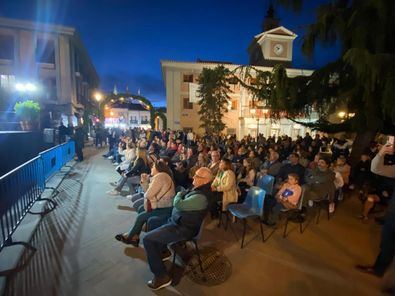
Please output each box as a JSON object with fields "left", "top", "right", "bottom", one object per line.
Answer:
{"left": 356, "top": 136, "right": 395, "bottom": 292}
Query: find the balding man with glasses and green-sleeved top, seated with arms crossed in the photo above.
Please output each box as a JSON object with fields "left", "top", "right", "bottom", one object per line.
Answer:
{"left": 143, "top": 168, "right": 213, "bottom": 290}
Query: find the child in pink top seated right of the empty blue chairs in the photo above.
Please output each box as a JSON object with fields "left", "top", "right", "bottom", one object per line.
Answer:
{"left": 271, "top": 173, "right": 302, "bottom": 224}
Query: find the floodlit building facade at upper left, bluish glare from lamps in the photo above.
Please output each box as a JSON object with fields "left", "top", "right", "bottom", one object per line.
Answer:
{"left": 0, "top": 18, "right": 99, "bottom": 124}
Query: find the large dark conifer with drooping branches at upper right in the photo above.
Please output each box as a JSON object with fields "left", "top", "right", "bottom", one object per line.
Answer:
{"left": 244, "top": 0, "right": 395, "bottom": 159}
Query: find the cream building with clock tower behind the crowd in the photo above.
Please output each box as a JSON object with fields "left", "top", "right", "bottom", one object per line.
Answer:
{"left": 161, "top": 26, "right": 318, "bottom": 138}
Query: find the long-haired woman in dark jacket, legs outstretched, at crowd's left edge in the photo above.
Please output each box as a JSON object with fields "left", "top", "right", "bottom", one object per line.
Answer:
{"left": 107, "top": 148, "right": 150, "bottom": 195}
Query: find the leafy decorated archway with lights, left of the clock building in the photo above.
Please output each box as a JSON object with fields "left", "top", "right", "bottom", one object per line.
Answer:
{"left": 101, "top": 93, "right": 167, "bottom": 129}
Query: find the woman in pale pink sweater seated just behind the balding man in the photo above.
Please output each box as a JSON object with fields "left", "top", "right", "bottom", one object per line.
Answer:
{"left": 115, "top": 161, "right": 175, "bottom": 247}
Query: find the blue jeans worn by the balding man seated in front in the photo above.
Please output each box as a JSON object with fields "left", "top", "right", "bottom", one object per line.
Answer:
{"left": 143, "top": 222, "right": 194, "bottom": 278}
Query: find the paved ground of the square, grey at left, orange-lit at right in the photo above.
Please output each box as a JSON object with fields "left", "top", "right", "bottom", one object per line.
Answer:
{"left": 5, "top": 148, "right": 381, "bottom": 296}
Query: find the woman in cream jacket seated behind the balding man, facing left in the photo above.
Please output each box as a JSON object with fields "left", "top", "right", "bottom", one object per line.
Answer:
{"left": 211, "top": 158, "right": 238, "bottom": 214}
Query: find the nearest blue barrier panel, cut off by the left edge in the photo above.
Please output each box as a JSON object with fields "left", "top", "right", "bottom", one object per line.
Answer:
{"left": 0, "top": 156, "right": 45, "bottom": 251}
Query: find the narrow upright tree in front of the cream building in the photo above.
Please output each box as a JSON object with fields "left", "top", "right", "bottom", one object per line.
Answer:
{"left": 198, "top": 65, "right": 231, "bottom": 134}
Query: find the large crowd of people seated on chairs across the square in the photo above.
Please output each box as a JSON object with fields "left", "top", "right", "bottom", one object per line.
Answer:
{"left": 98, "top": 129, "right": 391, "bottom": 289}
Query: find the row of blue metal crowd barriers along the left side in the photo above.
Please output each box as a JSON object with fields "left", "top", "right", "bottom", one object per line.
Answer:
{"left": 0, "top": 141, "right": 75, "bottom": 251}
